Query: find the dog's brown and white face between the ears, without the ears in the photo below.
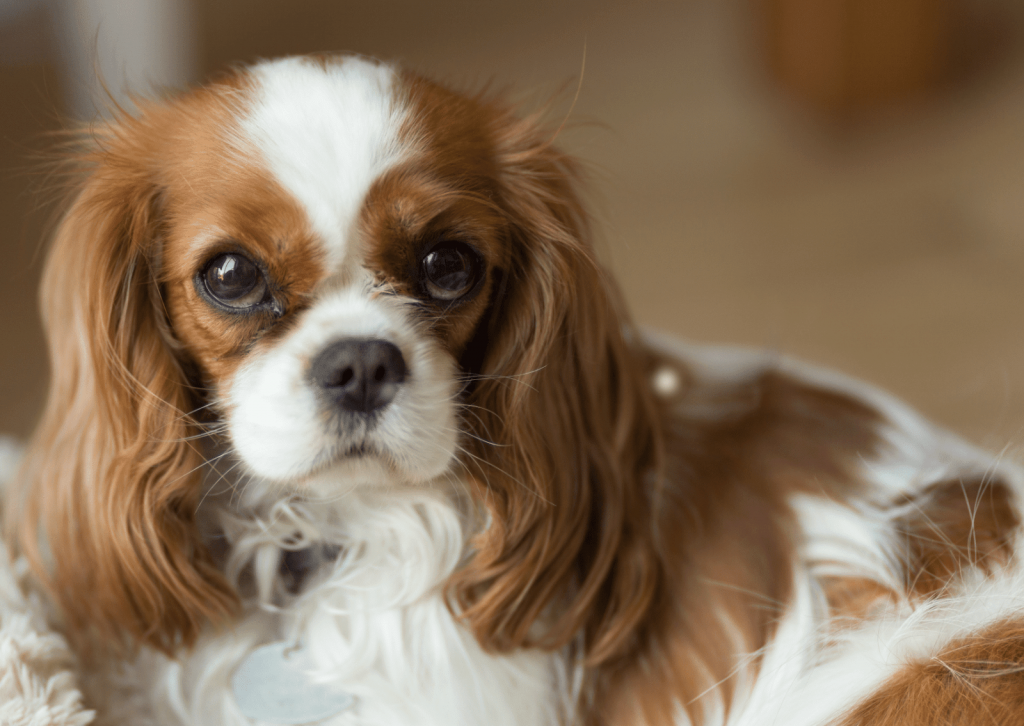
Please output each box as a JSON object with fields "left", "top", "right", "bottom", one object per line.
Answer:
{"left": 159, "top": 58, "right": 511, "bottom": 488}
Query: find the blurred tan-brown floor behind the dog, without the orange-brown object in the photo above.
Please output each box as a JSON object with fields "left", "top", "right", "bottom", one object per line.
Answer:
{"left": 0, "top": 0, "right": 1024, "bottom": 450}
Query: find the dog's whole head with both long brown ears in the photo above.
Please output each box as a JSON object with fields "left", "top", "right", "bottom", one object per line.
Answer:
{"left": 14, "top": 57, "right": 656, "bottom": 658}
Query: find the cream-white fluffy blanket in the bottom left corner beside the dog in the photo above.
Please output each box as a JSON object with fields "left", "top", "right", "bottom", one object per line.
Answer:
{"left": 0, "top": 437, "right": 94, "bottom": 726}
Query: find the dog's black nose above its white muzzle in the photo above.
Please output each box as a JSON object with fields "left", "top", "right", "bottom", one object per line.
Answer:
{"left": 309, "top": 338, "right": 406, "bottom": 414}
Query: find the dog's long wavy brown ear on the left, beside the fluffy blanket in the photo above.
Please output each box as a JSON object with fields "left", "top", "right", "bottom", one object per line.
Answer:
{"left": 7, "top": 127, "right": 236, "bottom": 651}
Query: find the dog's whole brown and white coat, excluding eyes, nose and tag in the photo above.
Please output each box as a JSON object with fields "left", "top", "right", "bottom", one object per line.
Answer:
{"left": 7, "top": 57, "right": 1024, "bottom": 726}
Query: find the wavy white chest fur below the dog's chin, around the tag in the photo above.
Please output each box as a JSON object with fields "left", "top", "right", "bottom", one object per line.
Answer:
{"left": 90, "top": 487, "right": 564, "bottom": 726}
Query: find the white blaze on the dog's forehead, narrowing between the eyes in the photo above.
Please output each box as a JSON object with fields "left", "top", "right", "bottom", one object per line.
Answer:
{"left": 242, "top": 57, "right": 407, "bottom": 270}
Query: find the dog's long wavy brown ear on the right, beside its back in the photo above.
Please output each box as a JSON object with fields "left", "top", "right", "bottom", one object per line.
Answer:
{"left": 453, "top": 111, "right": 660, "bottom": 664}
